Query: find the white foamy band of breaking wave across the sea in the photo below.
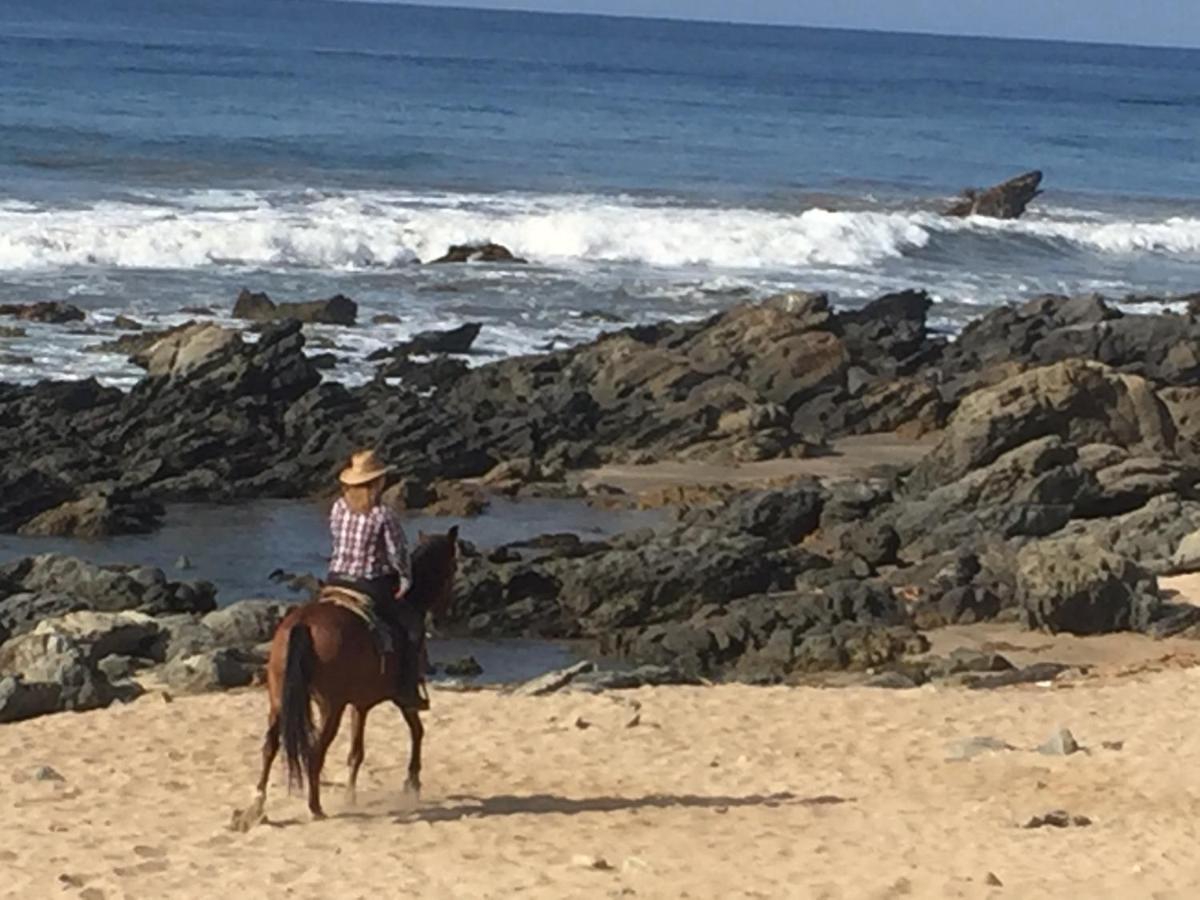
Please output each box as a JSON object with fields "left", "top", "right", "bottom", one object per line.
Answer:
{"left": 0, "top": 191, "right": 1200, "bottom": 271}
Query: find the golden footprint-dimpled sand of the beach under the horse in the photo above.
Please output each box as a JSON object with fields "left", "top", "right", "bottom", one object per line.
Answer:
{"left": 7, "top": 666, "right": 1200, "bottom": 900}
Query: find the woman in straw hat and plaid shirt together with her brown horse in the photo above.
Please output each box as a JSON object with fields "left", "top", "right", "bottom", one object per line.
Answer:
{"left": 234, "top": 454, "right": 458, "bottom": 829}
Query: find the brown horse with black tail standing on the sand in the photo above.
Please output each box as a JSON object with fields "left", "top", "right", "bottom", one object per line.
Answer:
{"left": 235, "top": 526, "right": 458, "bottom": 824}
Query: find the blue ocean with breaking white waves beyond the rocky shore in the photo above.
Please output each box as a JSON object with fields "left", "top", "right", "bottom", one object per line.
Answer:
{"left": 0, "top": 0, "right": 1200, "bottom": 385}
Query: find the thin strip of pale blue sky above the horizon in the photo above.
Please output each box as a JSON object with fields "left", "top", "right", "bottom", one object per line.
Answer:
{"left": 372, "top": 0, "right": 1200, "bottom": 47}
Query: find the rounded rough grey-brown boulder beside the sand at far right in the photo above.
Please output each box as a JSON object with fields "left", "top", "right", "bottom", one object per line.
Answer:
{"left": 1016, "top": 538, "right": 1160, "bottom": 635}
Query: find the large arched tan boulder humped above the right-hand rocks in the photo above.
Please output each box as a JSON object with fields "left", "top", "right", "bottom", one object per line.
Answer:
{"left": 910, "top": 360, "right": 1176, "bottom": 492}
